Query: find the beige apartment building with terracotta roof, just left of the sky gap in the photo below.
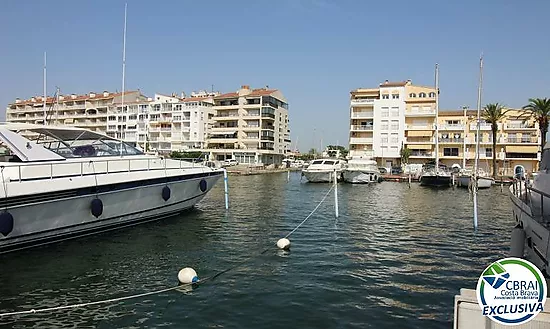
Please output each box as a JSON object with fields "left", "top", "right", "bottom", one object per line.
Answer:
{"left": 207, "top": 86, "right": 290, "bottom": 165}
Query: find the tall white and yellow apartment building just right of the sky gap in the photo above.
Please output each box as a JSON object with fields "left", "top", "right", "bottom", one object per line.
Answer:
{"left": 349, "top": 80, "right": 435, "bottom": 167}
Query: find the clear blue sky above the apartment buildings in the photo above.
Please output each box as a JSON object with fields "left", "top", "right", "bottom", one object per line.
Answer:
{"left": 0, "top": 0, "right": 550, "bottom": 151}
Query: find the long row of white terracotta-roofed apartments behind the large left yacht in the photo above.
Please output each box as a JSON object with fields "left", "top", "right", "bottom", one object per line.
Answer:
{"left": 6, "top": 91, "right": 219, "bottom": 153}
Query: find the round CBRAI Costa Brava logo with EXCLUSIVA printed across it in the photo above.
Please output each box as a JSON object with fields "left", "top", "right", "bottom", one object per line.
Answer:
{"left": 476, "top": 258, "right": 546, "bottom": 325}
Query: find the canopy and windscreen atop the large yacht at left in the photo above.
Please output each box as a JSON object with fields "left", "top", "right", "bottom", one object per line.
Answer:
{"left": 0, "top": 124, "right": 143, "bottom": 162}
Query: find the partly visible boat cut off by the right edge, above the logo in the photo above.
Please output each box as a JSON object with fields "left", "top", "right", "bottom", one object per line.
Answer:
{"left": 510, "top": 144, "right": 550, "bottom": 276}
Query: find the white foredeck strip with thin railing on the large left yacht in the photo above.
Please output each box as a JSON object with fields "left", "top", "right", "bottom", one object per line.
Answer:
{"left": 0, "top": 158, "right": 210, "bottom": 182}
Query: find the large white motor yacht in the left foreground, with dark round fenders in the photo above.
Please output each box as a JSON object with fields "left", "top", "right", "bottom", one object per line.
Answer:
{"left": 0, "top": 124, "right": 223, "bottom": 253}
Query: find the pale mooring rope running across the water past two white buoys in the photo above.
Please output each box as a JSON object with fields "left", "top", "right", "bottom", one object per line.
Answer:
{"left": 0, "top": 184, "right": 334, "bottom": 318}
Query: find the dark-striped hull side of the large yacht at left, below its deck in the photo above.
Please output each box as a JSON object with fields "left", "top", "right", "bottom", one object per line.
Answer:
{"left": 0, "top": 172, "right": 221, "bottom": 253}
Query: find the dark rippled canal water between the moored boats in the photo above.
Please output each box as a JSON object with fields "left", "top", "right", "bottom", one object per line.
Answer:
{"left": 0, "top": 173, "right": 513, "bottom": 329}
